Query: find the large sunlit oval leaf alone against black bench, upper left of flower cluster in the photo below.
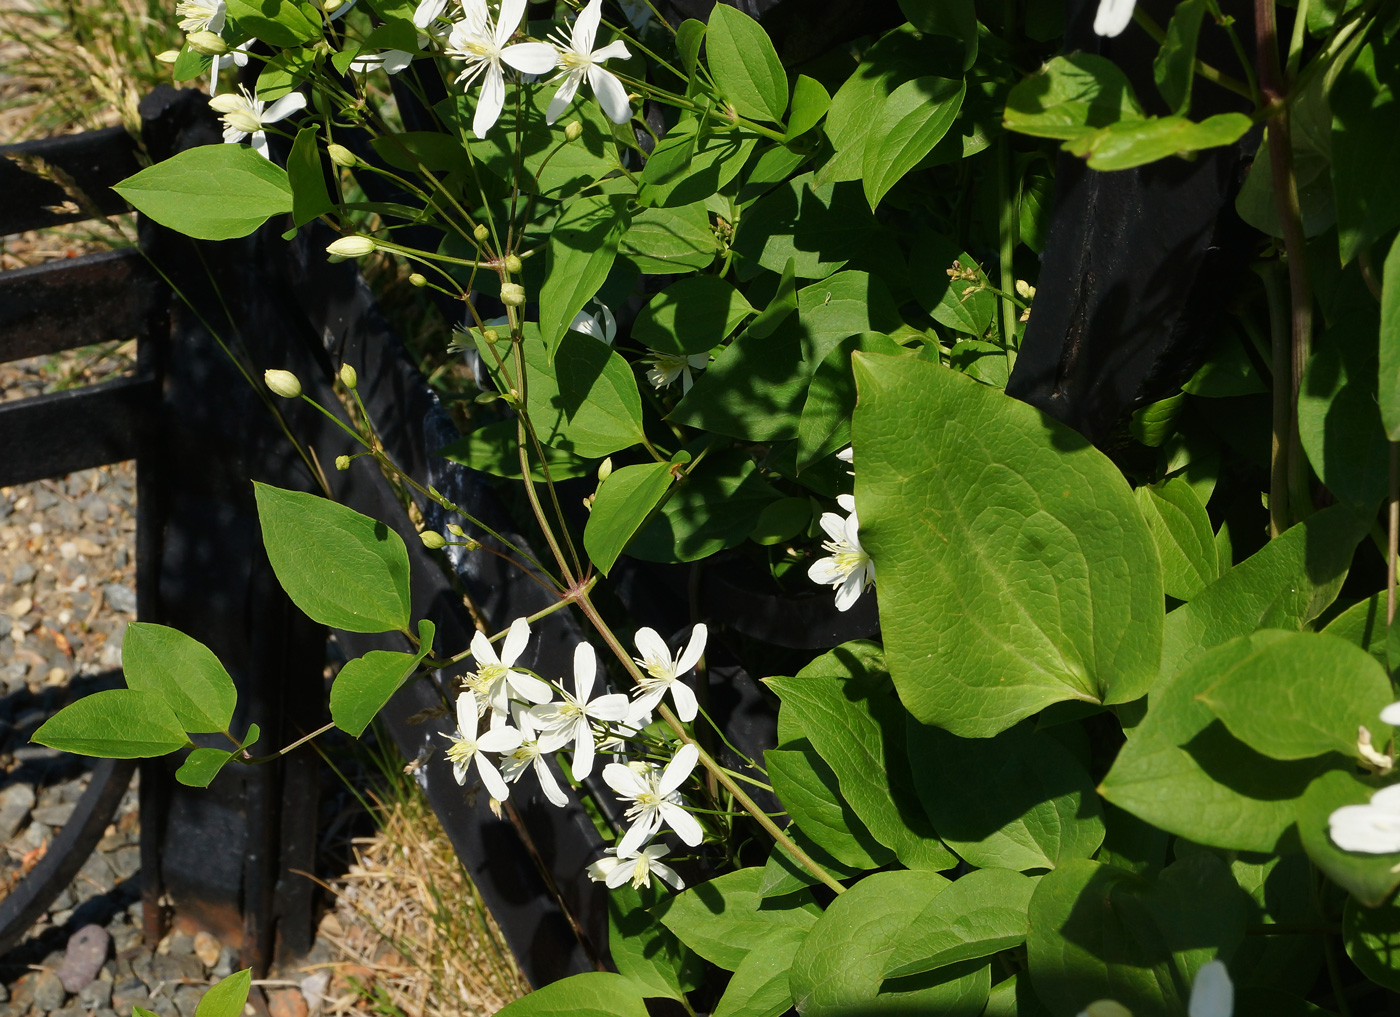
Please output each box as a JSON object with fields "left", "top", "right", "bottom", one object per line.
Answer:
{"left": 253, "top": 482, "right": 409, "bottom": 632}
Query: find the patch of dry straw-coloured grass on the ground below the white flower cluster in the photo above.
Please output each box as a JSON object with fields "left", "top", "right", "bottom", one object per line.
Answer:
{"left": 319, "top": 780, "right": 529, "bottom": 1017}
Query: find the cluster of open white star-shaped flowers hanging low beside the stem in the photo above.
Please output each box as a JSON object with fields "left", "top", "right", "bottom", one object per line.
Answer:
{"left": 444, "top": 618, "right": 707, "bottom": 890}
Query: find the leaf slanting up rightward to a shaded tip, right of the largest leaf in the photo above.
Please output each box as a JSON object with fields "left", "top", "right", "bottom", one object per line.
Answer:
{"left": 1159, "top": 506, "right": 1368, "bottom": 675}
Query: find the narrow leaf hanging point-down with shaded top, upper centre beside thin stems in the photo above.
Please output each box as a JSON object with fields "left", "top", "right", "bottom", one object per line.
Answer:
{"left": 539, "top": 195, "right": 627, "bottom": 357}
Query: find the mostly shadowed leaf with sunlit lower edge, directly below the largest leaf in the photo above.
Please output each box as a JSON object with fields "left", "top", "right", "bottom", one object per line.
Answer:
{"left": 907, "top": 722, "right": 1103, "bottom": 870}
